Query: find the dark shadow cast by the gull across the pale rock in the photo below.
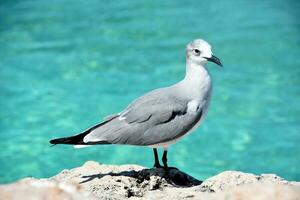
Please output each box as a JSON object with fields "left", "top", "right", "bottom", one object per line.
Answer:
{"left": 80, "top": 167, "right": 202, "bottom": 187}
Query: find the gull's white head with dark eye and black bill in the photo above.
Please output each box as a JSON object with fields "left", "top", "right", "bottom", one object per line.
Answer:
{"left": 186, "top": 39, "right": 223, "bottom": 66}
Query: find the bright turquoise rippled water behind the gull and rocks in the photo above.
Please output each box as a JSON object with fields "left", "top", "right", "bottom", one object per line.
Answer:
{"left": 0, "top": 0, "right": 300, "bottom": 183}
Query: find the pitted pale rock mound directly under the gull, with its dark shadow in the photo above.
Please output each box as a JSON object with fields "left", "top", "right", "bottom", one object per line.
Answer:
{"left": 51, "top": 161, "right": 201, "bottom": 199}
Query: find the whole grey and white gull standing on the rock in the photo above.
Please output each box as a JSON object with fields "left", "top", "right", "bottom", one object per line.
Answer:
{"left": 50, "top": 39, "right": 222, "bottom": 171}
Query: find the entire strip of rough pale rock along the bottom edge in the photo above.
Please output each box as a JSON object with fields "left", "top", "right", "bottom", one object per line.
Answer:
{"left": 0, "top": 161, "right": 300, "bottom": 200}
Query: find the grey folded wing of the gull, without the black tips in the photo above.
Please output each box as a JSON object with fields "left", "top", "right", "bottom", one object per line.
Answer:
{"left": 84, "top": 90, "right": 202, "bottom": 146}
